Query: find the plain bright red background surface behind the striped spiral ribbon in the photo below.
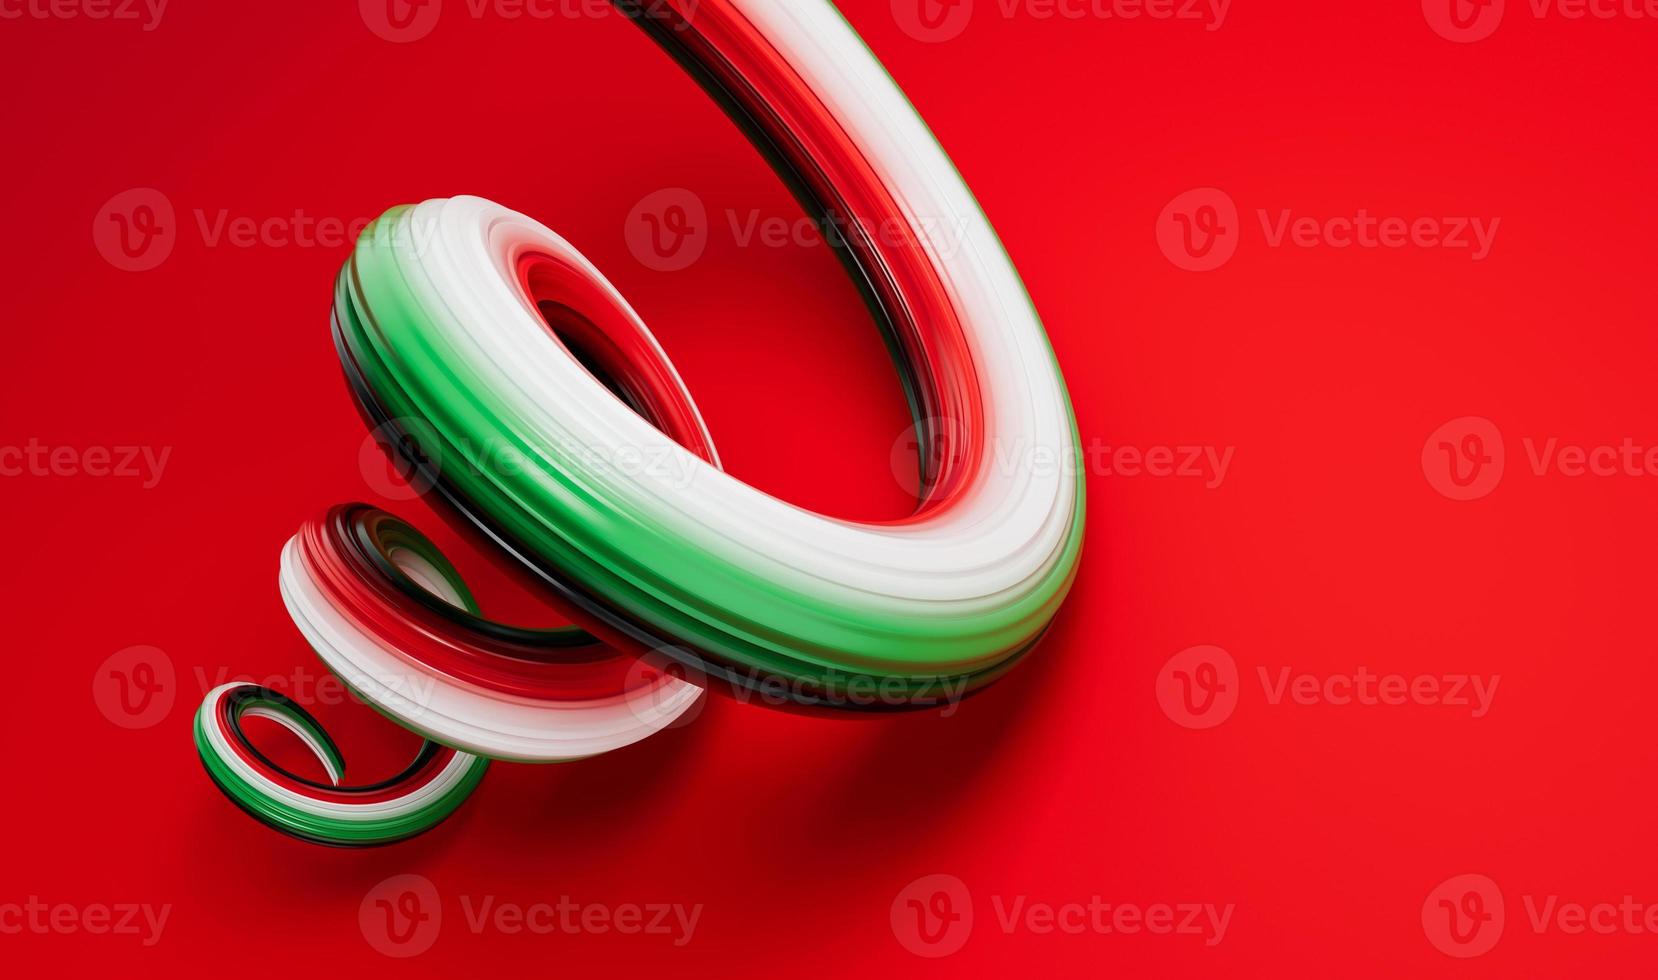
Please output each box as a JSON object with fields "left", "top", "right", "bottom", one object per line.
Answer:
{"left": 0, "top": 0, "right": 1658, "bottom": 977}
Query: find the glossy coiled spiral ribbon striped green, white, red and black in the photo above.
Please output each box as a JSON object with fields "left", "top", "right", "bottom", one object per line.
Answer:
{"left": 196, "top": 0, "right": 1083, "bottom": 846}
